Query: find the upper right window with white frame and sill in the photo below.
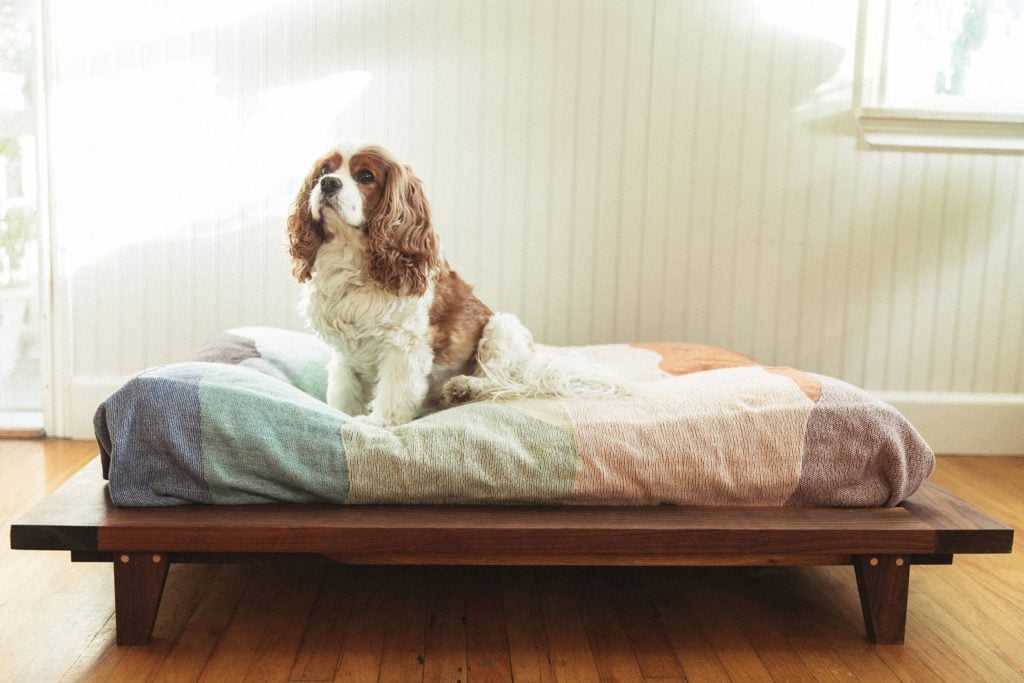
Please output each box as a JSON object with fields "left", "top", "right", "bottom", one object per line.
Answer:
{"left": 855, "top": 0, "right": 1024, "bottom": 152}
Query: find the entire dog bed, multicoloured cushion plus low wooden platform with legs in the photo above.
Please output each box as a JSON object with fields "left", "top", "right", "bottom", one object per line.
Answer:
{"left": 11, "top": 329, "right": 1013, "bottom": 645}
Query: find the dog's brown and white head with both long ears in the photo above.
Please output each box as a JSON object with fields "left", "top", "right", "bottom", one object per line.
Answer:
{"left": 288, "top": 142, "right": 440, "bottom": 296}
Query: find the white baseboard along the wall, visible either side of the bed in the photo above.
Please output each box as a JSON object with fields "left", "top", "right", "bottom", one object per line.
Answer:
{"left": 60, "top": 377, "right": 1024, "bottom": 456}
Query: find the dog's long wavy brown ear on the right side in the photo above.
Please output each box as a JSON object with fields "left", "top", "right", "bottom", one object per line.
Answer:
{"left": 367, "top": 162, "right": 441, "bottom": 296}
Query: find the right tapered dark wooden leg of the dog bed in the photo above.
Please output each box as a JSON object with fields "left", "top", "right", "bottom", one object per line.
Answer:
{"left": 853, "top": 555, "right": 910, "bottom": 645}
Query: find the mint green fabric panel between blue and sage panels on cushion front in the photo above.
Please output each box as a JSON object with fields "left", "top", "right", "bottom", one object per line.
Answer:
{"left": 199, "top": 366, "right": 348, "bottom": 505}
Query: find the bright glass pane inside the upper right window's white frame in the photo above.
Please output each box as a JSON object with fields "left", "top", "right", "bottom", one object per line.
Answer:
{"left": 885, "top": 0, "right": 1024, "bottom": 112}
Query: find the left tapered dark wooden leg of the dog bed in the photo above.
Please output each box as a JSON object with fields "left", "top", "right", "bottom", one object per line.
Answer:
{"left": 114, "top": 553, "right": 171, "bottom": 645}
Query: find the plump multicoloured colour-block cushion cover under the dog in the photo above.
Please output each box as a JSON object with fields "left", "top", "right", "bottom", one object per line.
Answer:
{"left": 94, "top": 328, "right": 934, "bottom": 506}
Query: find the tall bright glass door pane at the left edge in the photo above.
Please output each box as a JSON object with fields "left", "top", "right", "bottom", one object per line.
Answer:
{"left": 0, "top": 0, "right": 42, "bottom": 429}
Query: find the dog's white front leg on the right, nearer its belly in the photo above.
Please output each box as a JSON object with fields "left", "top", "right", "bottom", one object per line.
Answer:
{"left": 370, "top": 347, "right": 433, "bottom": 426}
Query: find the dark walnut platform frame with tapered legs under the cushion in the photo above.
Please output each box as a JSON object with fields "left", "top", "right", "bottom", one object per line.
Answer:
{"left": 10, "top": 458, "right": 1013, "bottom": 645}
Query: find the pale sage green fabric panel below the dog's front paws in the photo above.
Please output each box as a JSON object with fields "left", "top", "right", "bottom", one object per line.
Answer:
{"left": 342, "top": 400, "right": 579, "bottom": 505}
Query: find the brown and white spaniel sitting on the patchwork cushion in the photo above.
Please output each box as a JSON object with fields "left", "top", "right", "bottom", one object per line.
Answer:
{"left": 288, "top": 142, "right": 624, "bottom": 426}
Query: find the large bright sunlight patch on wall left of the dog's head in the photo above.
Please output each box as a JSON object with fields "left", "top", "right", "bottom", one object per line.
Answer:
{"left": 54, "top": 67, "right": 371, "bottom": 271}
